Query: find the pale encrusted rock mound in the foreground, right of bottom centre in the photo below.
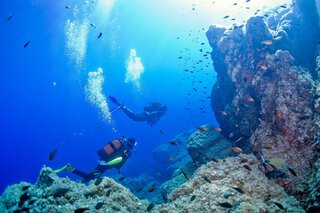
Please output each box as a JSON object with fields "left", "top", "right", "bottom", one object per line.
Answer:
{"left": 154, "top": 155, "right": 304, "bottom": 212}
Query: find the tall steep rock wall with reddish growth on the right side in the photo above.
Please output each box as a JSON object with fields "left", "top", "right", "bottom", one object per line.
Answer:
{"left": 207, "top": 1, "right": 320, "bottom": 191}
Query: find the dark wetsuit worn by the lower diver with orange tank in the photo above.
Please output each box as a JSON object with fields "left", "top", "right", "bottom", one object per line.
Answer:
{"left": 72, "top": 142, "right": 131, "bottom": 182}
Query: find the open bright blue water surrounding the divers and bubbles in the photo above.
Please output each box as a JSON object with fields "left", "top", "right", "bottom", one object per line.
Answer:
{"left": 0, "top": 0, "right": 288, "bottom": 191}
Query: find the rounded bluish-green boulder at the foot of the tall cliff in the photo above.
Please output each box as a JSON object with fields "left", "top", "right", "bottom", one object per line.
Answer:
{"left": 187, "top": 125, "right": 232, "bottom": 165}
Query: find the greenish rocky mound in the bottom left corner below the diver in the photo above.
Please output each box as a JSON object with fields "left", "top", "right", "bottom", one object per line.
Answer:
{"left": 0, "top": 167, "right": 148, "bottom": 212}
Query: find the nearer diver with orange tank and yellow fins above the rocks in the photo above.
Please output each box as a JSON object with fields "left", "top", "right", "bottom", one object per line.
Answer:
{"left": 54, "top": 137, "right": 137, "bottom": 182}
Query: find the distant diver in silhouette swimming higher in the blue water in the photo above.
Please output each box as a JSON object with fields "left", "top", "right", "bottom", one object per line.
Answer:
{"left": 109, "top": 96, "right": 167, "bottom": 126}
